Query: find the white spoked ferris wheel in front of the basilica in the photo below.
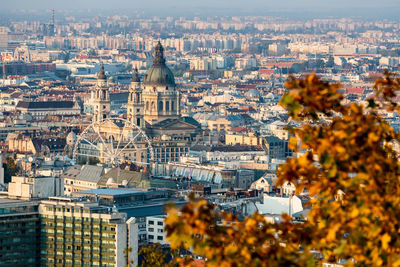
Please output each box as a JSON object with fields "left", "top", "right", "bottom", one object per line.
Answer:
{"left": 73, "top": 118, "right": 154, "bottom": 166}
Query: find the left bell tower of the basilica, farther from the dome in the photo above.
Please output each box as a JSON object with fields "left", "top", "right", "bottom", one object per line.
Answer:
{"left": 93, "top": 64, "right": 111, "bottom": 122}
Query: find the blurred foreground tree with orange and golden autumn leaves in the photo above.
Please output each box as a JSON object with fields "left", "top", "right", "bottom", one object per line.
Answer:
{"left": 140, "top": 73, "right": 400, "bottom": 266}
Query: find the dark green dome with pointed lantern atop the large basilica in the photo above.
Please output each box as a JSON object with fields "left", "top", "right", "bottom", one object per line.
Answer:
{"left": 143, "top": 42, "right": 175, "bottom": 86}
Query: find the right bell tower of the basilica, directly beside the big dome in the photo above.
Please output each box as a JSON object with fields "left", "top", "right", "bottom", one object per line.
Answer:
{"left": 126, "top": 67, "right": 145, "bottom": 128}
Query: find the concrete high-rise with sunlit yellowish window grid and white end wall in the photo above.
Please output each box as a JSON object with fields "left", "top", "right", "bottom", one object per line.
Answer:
{"left": 39, "top": 198, "right": 138, "bottom": 267}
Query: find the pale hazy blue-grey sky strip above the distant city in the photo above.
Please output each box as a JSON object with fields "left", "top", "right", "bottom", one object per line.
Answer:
{"left": 0, "top": 0, "right": 400, "bottom": 17}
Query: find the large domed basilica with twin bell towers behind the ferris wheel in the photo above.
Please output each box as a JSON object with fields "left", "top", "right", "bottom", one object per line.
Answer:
{"left": 93, "top": 42, "right": 202, "bottom": 166}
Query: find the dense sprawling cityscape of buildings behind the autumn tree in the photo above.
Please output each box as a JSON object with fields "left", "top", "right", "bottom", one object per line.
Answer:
{"left": 0, "top": 1, "right": 400, "bottom": 267}
